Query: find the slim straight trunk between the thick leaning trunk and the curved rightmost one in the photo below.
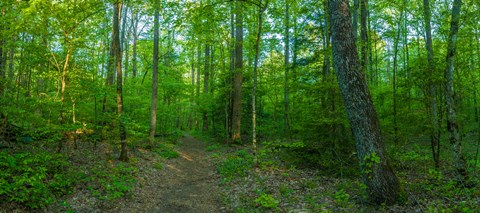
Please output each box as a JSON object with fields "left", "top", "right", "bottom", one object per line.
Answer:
{"left": 423, "top": 0, "right": 440, "bottom": 168}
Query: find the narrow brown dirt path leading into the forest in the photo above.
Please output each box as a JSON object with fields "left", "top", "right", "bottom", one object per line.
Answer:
{"left": 147, "top": 134, "right": 225, "bottom": 212}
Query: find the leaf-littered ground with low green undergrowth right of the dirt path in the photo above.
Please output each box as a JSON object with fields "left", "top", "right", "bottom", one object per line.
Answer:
{"left": 207, "top": 133, "right": 480, "bottom": 212}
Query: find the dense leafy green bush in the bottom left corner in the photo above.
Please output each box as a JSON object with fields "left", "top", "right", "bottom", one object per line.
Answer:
{"left": 0, "top": 151, "right": 76, "bottom": 208}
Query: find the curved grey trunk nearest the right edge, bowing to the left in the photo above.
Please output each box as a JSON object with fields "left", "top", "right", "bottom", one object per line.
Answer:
{"left": 445, "top": 0, "right": 468, "bottom": 182}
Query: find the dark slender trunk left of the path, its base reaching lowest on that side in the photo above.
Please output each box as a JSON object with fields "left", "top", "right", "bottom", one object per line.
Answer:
{"left": 112, "top": 1, "right": 128, "bottom": 162}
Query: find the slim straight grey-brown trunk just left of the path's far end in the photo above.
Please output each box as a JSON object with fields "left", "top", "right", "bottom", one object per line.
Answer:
{"left": 149, "top": 0, "right": 160, "bottom": 146}
